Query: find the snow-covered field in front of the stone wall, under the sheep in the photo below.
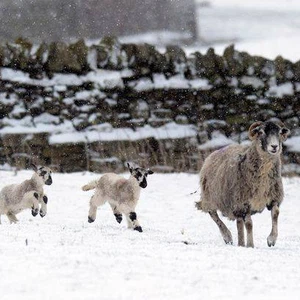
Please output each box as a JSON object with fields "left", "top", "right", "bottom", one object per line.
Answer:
{"left": 0, "top": 171, "right": 300, "bottom": 300}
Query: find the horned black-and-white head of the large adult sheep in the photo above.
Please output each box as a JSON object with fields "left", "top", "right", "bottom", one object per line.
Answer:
{"left": 249, "top": 121, "right": 290, "bottom": 156}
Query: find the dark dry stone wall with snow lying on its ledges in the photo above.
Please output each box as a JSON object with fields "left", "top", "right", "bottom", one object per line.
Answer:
{"left": 0, "top": 37, "right": 300, "bottom": 174}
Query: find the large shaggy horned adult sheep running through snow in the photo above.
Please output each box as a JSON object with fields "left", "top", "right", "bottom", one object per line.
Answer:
{"left": 196, "top": 121, "right": 290, "bottom": 247}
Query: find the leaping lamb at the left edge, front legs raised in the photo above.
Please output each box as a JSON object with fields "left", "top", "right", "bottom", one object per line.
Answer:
{"left": 0, "top": 164, "right": 52, "bottom": 224}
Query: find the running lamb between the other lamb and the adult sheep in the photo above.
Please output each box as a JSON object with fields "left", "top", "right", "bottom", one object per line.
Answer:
{"left": 82, "top": 163, "right": 153, "bottom": 232}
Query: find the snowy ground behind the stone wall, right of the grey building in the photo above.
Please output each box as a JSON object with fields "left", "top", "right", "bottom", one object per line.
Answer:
{"left": 188, "top": 0, "right": 300, "bottom": 61}
